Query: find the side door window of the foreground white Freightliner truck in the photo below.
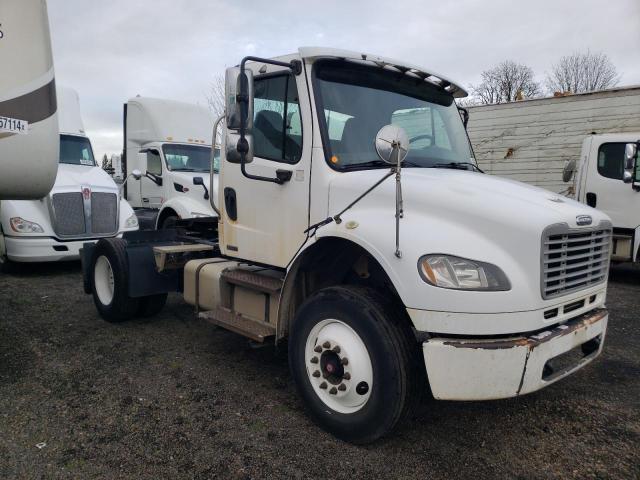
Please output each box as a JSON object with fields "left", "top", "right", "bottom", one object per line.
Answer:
{"left": 252, "top": 75, "right": 302, "bottom": 163}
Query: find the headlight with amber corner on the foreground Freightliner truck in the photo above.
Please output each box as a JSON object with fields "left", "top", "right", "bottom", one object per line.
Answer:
{"left": 418, "top": 254, "right": 511, "bottom": 291}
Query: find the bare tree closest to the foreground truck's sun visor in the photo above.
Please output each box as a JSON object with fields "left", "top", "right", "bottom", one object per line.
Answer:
{"left": 471, "top": 60, "right": 541, "bottom": 105}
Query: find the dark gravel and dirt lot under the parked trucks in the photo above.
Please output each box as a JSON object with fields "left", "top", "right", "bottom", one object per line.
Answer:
{"left": 0, "top": 264, "right": 640, "bottom": 479}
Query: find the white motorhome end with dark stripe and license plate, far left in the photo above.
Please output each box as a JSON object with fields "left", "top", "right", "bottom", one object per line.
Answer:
{"left": 0, "top": 0, "right": 58, "bottom": 199}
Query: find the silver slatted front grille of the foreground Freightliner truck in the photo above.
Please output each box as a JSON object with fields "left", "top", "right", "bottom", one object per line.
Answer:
{"left": 541, "top": 224, "right": 612, "bottom": 299}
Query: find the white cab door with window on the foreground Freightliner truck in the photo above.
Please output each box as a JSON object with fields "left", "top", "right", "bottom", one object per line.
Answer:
{"left": 218, "top": 60, "right": 311, "bottom": 267}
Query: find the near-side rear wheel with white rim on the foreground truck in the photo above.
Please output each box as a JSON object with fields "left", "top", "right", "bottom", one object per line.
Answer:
{"left": 89, "top": 238, "right": 140, "bottom": 322}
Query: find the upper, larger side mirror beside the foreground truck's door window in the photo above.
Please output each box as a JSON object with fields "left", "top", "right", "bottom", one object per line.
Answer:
{"left": 224, "top": 67, "right": 253, "bottom": 133}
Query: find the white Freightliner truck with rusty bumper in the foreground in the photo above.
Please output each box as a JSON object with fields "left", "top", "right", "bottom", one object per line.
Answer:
{"left": 82, "top": 48, "right": 611, "bottom": 443}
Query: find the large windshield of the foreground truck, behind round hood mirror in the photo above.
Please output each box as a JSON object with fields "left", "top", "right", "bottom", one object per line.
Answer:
{"left": 315, "top": 60, "right": 475, "bottom": 169}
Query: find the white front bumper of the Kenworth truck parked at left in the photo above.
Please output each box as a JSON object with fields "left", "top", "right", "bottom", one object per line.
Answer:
{"left": 4, "top": 234, "right": 122, "bottom": 262}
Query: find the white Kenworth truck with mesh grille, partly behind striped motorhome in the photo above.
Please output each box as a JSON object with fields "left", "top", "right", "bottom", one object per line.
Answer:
{"left": 0, "top": 88, "right": 138, "bottom": 269}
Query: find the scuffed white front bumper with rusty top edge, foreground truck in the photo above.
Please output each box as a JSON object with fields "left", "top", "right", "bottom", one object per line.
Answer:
{"left": 422, "top": 308, "right": 609, "bottom": 400}
